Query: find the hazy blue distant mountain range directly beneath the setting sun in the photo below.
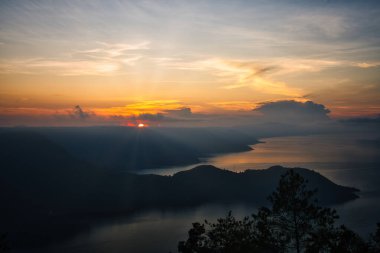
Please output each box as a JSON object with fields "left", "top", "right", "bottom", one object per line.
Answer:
{"left": 0, "top": 127, "right": 258, "bottom": 171}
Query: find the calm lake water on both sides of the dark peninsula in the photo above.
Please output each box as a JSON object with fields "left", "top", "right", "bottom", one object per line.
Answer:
{"left": 34, "top": 133, "right": 380, "bottom": 253}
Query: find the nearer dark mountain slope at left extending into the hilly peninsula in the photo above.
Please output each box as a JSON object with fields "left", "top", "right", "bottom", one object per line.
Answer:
{"left": 0, "top": 129, "right": 358, "bottom": 247}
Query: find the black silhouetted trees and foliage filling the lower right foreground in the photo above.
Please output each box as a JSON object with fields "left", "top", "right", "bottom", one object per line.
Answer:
{"left": 178, "top": 170, "right": 380, "bottom": 253}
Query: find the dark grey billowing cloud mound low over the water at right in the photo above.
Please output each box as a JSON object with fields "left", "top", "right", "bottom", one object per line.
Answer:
{"left": 254, "top": 100, "right": 330, "bottom": 121}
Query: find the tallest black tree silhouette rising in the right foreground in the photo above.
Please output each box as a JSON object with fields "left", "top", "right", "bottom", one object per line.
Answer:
{"left": 269, "top": 170, "right": 338, "bottom": 253}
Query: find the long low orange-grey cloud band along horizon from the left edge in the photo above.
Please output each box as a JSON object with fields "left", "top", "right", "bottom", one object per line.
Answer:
{"left": 0, "top": 100, "right": 336, "bottom": 127}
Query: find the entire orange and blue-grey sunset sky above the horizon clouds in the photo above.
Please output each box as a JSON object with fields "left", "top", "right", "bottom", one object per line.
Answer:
{"left": 0, "top": 0, "right": 380, "bottom": 126}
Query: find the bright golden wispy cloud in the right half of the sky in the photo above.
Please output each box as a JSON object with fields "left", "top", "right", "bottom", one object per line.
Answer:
{"left": 157, "top": 57, "right": 372, "bottom": 99}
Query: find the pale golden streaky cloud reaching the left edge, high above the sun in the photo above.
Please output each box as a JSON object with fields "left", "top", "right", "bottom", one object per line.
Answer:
{"left": 0, "top": 41, "right": 150, "bottom": 76}
